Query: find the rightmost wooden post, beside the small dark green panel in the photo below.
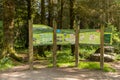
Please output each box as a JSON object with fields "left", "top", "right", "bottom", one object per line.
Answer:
{"left": 100, "top": 25, "right": 104, "bottom": 70}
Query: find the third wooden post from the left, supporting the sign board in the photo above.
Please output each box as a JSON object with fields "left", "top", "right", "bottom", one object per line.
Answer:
{"left": 75, "top": 22, "right": 79, "bottom": 67}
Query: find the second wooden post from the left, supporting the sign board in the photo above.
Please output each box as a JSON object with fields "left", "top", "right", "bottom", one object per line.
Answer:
{"left": 53, "top": 19, "right": 57, "bottom": 67}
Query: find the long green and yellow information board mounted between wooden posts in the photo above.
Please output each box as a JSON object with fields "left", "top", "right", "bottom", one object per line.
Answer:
{"left": 33, "top": 26, "right": 111, "bottom": 46}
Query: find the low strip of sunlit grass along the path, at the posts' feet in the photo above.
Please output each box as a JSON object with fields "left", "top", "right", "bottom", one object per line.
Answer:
{"left": 48, "top": 61, "right": 116, "bottom": 72}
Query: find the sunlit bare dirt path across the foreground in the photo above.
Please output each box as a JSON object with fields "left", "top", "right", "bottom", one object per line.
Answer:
{"left": 0, "top": 62, "right": 120, "bottom": 80}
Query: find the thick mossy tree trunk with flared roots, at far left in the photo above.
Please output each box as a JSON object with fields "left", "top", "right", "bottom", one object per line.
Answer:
{"left": 1, "top": 0, "right": 21, "bottom": 61}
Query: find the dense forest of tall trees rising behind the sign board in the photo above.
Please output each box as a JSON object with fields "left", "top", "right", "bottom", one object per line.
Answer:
{"left": 0, "top": 0, "right": 120, "bottom": 70}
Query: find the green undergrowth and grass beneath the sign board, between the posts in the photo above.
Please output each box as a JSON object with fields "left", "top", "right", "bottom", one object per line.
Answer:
{"left": 46, "top": 46, "right": 116, "bottom": 72}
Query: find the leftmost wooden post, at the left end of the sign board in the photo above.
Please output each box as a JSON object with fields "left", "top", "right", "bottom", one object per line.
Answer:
{"left": 28, "top": 19, "right": 33, "bottom": 70}
